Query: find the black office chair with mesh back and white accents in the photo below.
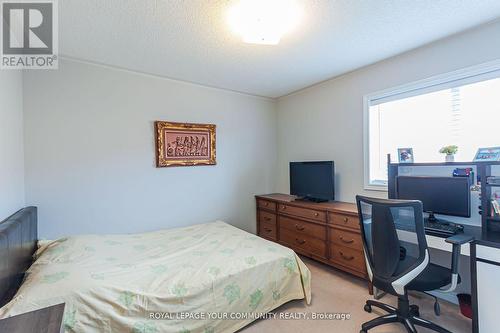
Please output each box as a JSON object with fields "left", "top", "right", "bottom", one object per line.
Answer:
{"left": 356, "top": 196, "right": 472, "bottom": 333}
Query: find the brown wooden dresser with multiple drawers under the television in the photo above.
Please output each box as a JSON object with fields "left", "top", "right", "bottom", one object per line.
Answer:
{"left": 256, "top": 194, "right": 371, "bottom": 290}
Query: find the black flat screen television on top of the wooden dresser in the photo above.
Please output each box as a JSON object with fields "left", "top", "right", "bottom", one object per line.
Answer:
{"left": 290, "top": 161, "right": 335, "bottom": 202}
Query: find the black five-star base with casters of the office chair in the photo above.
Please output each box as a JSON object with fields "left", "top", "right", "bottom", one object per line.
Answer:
{"left": 360, "top": 295, "right": 451, "bottom": 333}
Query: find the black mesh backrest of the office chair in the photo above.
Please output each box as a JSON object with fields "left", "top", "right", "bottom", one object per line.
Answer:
{"left": 356, "top": 196, "right": 427, "bottom": 280}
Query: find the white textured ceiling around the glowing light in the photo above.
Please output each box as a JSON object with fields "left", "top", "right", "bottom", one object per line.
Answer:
{"left": 59, "top": 0, "right": 500, "bottom": 97}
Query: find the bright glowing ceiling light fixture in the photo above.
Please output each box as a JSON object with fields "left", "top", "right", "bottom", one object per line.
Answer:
{"left": 228, "top": 0, "right": 301, "bottom": 45}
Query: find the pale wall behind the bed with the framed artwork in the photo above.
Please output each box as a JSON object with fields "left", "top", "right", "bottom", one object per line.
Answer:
{"left": 24, "top": 60, "right": 276, "bottom": 238}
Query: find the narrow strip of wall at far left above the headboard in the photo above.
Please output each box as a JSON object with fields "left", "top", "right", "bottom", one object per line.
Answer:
{"left": 0, "top": 70, "right": 24, "bottom": 221}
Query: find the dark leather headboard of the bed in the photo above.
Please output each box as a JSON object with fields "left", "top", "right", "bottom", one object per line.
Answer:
{"left": 0, "top": 207, "right": 38, "bottom": 307}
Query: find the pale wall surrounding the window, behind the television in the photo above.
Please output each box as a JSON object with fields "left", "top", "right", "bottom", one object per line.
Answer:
{"left": 276, "top": 21, "right": 500, "bottom": 202}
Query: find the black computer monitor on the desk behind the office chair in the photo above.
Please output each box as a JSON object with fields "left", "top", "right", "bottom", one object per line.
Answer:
{"left": 395, "top": 176, "right": 471, "bottom": 219}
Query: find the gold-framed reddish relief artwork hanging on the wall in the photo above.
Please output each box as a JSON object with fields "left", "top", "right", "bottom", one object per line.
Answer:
{"left": 155, "top": 121, "right": 216, "bottom": 168}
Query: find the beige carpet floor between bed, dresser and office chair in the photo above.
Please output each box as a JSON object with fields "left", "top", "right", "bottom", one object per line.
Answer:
{"left": 240, "top": 258, "right": 472, "bottom": 333}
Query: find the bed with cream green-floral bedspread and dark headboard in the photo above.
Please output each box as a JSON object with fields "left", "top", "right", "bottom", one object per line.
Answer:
{"left": 0, "top": 207, "right": 311, "bottom": 333}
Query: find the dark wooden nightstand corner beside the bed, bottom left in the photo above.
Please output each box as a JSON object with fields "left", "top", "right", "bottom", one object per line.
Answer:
{"left": 0, "top": 303, "right": 64, "bottom": 333}
